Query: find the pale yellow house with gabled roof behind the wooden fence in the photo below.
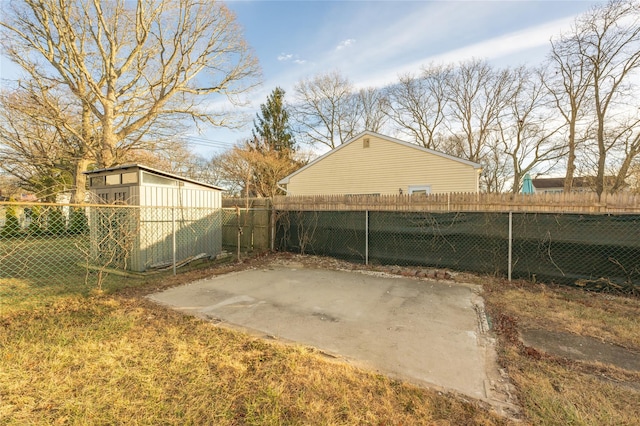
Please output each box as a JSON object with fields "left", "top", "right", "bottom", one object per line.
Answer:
{"left": 278, "top": 131, "right": 482, "bottom": 195}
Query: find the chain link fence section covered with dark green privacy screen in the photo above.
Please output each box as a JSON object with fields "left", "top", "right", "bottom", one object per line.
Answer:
{"left": 276, "top": 211, "right": 640, "bottom": 294}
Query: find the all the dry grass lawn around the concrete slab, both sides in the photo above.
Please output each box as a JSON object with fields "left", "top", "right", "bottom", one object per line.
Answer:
{"left": 0, "top": 256, "right": 640, "bottom": 425}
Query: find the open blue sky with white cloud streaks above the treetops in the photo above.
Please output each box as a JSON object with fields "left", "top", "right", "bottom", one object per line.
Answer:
{"left": 188, "top": 0, "right": 598, "bottom": 157}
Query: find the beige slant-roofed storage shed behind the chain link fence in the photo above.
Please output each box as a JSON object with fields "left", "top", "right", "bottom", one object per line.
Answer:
{"left": 85, "top": 164, "right": 222, "bottom": 272}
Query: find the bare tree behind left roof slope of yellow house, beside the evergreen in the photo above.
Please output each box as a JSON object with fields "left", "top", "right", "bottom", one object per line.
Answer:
{"left": 292, "top": 71, "right": 357, "bottom": 149}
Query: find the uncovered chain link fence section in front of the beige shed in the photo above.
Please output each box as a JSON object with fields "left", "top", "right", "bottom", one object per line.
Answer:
{"left": 0, "top": 203, "right": 223, "bottom": 310}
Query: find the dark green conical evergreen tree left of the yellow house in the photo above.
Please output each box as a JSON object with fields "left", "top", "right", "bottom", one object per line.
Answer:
{"left": 252, "top": 87, "right": 295, "bottom": 156}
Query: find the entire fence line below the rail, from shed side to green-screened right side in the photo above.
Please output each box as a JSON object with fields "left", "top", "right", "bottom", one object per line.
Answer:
{"left": 6, "top": 202, "right": 640, "bottom": 307}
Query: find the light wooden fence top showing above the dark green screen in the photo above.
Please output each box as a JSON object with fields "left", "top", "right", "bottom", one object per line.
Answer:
{"left": 272, "top": 193, "right": 640, "bottom": 214}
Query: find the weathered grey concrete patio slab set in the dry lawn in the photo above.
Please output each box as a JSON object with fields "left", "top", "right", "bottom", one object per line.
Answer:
{"left": 149, "top": 265, "right": 506, "bottom": 408}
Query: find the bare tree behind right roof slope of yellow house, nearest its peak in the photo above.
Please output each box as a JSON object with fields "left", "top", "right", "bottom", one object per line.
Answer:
{"left": 388, "top": 65, "right": 452, "bottom": 150}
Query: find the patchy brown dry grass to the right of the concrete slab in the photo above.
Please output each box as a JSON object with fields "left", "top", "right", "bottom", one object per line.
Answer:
{"left": 484, "top": 280, "right": 640, "bottom": 425}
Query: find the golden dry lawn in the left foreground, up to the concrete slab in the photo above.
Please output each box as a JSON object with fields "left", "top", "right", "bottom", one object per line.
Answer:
{"left": 0, "top": 262, "right": 509, "bottom": 425}
